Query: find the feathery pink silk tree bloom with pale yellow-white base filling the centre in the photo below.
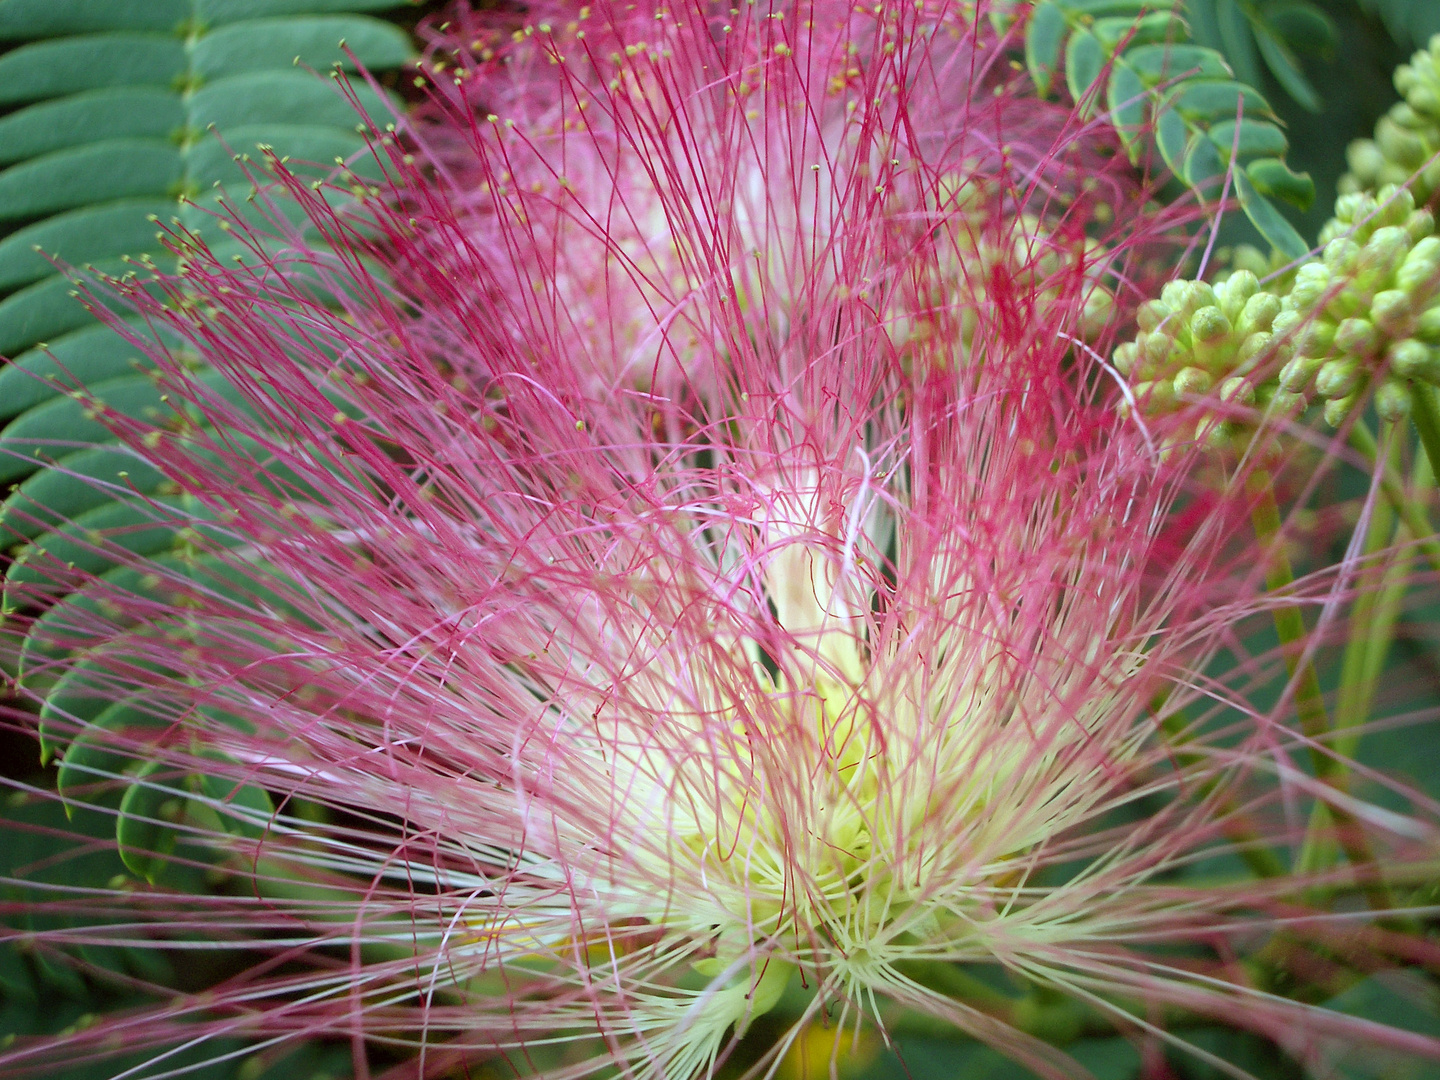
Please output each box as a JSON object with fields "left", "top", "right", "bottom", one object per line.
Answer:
{"left": 0, "top": 1, "right": 1440, "bottom": 1080}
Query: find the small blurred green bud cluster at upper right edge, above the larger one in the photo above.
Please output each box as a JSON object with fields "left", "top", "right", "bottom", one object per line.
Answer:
{"left": 1341, "top": 35, "right": 1440, "bottom": 203}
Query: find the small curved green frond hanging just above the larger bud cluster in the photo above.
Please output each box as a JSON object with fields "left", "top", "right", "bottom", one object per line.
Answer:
{"left": 1014, "top": 0, "right": 1315, "bottom": 259}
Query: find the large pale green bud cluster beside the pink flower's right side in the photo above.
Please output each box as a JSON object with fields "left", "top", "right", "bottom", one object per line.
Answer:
{"left": 1115, "top": 187, "right": 1440, "bottom": 431}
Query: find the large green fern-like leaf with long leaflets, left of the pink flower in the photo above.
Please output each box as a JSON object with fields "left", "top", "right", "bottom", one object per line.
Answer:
{"left": 0, "top": 0, "right": 412, "bottom": 904}
